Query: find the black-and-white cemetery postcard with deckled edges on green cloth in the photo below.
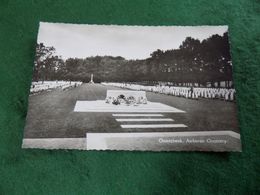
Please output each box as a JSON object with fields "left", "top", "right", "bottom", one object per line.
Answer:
{"left": 22, "top": 22, "right": 241, "bottom": 151}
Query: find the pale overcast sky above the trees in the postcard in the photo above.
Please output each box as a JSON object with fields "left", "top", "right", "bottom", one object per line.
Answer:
{"left": 37, "top": 22, "right": 228, "bottom": 59}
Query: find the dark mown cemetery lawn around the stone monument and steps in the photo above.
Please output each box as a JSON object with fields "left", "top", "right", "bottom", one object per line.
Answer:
{"left": 24, "top": 84, "right": 239, "bottom": 138}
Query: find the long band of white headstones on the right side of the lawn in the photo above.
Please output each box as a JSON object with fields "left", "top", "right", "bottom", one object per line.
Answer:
{"left": 102, "top": 83, "right": 236, "bottom": 101}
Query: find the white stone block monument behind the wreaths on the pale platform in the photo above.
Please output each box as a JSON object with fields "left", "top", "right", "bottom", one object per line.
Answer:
{"left": 106, "top": 90, "right": 146, "bottom": 99}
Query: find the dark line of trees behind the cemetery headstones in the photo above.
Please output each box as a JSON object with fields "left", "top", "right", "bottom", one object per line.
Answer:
{"left": 33, "top": 33, "right": 232, "bottom": 87}
